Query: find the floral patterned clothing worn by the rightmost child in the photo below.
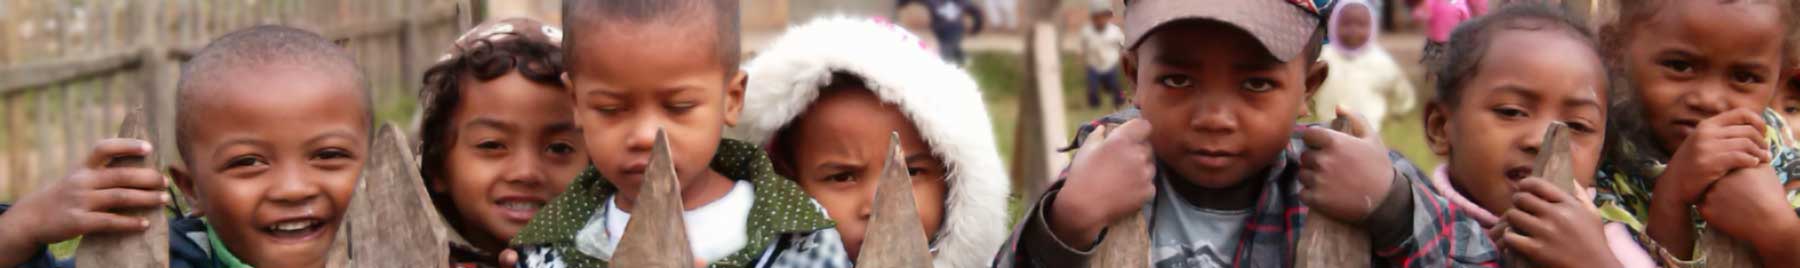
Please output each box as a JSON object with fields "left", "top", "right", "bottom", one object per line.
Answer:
{"left": 1593, "top": 110, "right": 1800, "bottom": 264}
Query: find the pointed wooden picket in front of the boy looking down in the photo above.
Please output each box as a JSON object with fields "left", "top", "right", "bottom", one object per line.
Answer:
{"left": 612, "top": 128, "right": 695, "bottom": 268}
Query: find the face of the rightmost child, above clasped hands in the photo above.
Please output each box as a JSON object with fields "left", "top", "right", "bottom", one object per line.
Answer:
{"left": 1624, "top": 2, "right": 1784, "bottom": 151}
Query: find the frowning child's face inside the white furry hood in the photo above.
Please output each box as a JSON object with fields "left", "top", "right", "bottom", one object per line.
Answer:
{"left": 781, "top": 86, "right": 949, "bottom": 257}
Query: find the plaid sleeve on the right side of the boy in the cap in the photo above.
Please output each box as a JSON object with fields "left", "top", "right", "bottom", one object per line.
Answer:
{"left": 1370, "top": 153, "right": 1499, "bottom": 268}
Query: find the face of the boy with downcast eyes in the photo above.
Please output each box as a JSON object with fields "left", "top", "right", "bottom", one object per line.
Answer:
{"left": 567, "top": 22, "right": 743, "bottom": 205}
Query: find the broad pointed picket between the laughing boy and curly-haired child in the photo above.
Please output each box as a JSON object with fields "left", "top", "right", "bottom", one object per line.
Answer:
{"left": 338, "top": 122, "right": 450, "bottom": 266}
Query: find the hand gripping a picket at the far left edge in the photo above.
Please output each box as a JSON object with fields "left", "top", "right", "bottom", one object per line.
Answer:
{"left": 0, "top": 138, "right": 169, "bottom": 245}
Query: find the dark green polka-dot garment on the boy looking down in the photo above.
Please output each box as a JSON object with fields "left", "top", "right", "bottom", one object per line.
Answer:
{"left": 511, "top": 138, "right": 846, "bottom": 268}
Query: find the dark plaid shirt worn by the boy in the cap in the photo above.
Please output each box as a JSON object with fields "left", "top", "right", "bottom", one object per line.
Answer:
{"left": 995, "top": 112, "right": 1499, "bottom": 268}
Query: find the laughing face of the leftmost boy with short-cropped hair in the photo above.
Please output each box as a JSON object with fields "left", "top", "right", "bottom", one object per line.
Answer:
{"left": 171, "top": 67, "right": 369, "bottom": 266}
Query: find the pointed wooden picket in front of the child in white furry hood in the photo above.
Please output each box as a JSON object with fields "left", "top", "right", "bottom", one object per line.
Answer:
{"left": 857, "top": 133, "right": 931, "bottom": 268}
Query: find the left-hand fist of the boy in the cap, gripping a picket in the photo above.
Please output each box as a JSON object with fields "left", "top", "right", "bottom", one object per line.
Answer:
{"left": 1048, "top": 119, "right": 1156, "bottom": 245}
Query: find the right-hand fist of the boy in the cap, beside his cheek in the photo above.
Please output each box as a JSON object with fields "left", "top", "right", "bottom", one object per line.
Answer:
{"left": 1300, "top": 110, "right": 1395, "bottom": 225}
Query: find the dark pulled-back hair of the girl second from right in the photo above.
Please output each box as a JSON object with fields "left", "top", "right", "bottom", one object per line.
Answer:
{"left": 1427, "top": 2, "right": 1613, "bottom": 106}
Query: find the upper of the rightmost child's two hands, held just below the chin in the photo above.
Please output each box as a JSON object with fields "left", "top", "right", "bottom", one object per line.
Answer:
{"left": 1651, "top": 108, "right": 1780, "bottom": 207}
